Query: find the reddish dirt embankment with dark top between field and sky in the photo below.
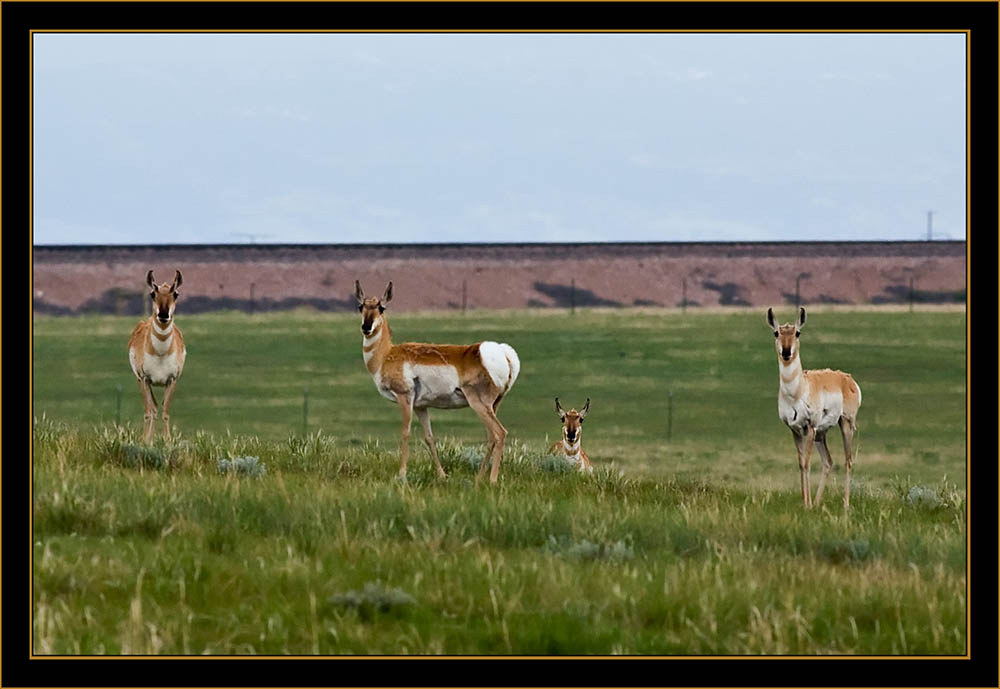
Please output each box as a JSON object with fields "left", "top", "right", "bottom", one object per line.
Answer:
{"left": 32, "top": 242, "right": 966, "bottom": 313}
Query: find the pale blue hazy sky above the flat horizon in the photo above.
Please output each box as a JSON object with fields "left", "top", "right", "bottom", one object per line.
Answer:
{"left": 33, "top": 33, "right": 966, "bottom": 244}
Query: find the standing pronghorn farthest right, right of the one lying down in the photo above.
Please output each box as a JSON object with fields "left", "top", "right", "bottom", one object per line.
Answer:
{"left": 767, "top": 307, "right": 861, "bottom": 509}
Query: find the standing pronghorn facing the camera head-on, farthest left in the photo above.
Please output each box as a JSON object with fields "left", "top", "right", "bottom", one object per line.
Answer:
{"left": 128, "top": 270, "right": 187, "bottom": 443}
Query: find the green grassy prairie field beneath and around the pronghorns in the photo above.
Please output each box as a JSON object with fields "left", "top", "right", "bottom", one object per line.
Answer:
{"left": 33, "top": 302, "right": 967, "bottom": 655}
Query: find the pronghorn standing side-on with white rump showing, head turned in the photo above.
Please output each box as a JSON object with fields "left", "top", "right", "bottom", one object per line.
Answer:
{"left": 354, "top": 280, "right": 521, "bottom": 484}
